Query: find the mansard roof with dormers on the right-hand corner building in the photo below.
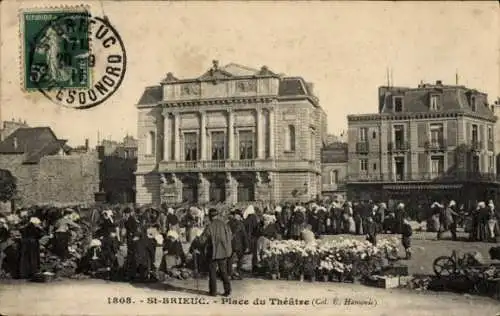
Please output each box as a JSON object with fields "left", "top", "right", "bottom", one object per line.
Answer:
{"left": 379, "top": 84, "right": 494, "bottom": 118}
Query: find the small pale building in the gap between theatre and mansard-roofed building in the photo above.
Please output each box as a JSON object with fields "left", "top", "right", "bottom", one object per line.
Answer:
{"left": 321, "top": 141, "right": 348, "bottom": 200}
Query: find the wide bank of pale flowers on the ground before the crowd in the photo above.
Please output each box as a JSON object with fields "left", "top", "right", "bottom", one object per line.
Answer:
{"left": 262, "top": 238, "right": 398, "bottom": 281}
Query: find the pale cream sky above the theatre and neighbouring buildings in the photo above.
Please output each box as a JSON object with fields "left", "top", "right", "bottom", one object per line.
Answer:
{"left": 0, "top": 1, "right": 500, "bottom": 146}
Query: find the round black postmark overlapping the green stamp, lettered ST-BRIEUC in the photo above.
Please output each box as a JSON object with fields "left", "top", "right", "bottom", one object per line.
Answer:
{"left": 26, "top": 12, "right": 127, "bottom": 109}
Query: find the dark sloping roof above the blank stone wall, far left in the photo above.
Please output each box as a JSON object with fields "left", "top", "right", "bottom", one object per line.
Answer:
{"left": 0, "top": 127, "right": 67, "bottom": 163}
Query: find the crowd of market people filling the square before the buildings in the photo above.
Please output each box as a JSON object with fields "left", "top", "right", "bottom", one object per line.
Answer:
{"left": 0, "top": 201, "right": 499, "bottom": 294}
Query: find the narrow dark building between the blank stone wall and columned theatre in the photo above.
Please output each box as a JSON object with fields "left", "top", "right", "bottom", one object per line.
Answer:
{"left": 97, "top": 135, "right": 138, "bottom": 204}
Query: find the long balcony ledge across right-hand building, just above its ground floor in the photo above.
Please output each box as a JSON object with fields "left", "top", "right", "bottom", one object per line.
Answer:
{"left": 347, "top": 171, "right": 500, "bottom": 183}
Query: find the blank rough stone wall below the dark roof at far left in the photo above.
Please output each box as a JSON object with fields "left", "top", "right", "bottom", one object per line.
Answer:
{"left": 0, "top": 153, "right": 99, "bottom": 207}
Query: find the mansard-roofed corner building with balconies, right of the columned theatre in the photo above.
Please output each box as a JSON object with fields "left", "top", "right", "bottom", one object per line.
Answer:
{"left": 347, "top": 81, "right": 498, "bottom": 205}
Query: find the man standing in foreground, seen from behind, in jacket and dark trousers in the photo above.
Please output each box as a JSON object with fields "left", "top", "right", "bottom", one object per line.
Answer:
{"left": 200, "top": 208, "right": 233, "bottom": 296}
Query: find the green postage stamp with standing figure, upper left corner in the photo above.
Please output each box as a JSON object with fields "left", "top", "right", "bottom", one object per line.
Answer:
{"left": 20, "top": 7, "right": 91, "bottom": 91}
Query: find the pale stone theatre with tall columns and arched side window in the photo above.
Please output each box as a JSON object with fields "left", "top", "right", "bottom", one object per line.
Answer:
{"left": 136, "top": 61, "right": 326, "bottom": 205}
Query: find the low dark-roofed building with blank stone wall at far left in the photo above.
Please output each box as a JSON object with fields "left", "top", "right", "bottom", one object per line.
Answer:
{"left": 0, "top": 127, "right": 99, "bottom": 207}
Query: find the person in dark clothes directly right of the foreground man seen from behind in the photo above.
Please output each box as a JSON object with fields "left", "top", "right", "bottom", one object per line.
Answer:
{"left": 228, "top": 210, "right": 249, "bottom": 280}
